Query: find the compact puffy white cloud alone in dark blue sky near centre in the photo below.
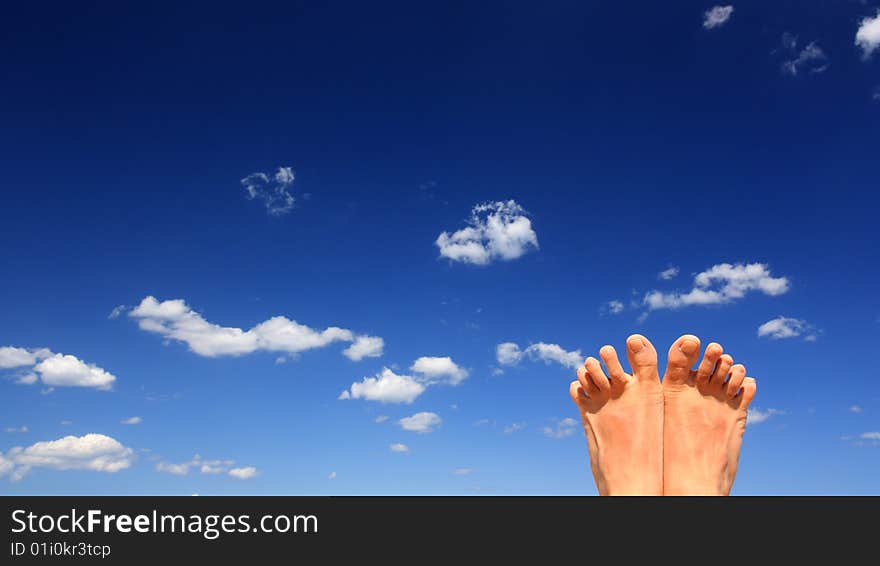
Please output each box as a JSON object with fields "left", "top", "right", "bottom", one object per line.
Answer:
{"left": 435, "top": 200, "right": 538, "bottom": 265}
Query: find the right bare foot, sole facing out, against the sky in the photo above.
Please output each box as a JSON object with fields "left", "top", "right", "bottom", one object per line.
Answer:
{"left": 663, "top": 334, "right": 756, "bottom": 495}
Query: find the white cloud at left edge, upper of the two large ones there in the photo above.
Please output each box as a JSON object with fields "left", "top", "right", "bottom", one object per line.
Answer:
{"left": 0, "top": 346, "right": 116, "bottom": 391}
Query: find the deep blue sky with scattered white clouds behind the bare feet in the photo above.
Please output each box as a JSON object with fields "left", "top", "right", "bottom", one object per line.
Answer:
{"left": 0, "top": 1, "right": 880, "bottom": 494}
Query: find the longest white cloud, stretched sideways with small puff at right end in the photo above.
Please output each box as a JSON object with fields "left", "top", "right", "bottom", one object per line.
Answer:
{"left": 128, "top": 296, "right": 384, "bottom": 360}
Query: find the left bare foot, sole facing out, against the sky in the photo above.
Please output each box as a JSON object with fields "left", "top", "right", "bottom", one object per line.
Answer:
{"left": 569, "top": 334, "right": 663, "bottom": 495}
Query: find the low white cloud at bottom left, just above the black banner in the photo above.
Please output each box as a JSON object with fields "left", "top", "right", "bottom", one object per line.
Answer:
{"left": 0, "top": 434, "right": 135, "bottom": 481}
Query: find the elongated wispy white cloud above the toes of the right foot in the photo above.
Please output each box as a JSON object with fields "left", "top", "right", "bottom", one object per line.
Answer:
{"left": 644, "top": 263, "right": 789, "bottom": 310}
